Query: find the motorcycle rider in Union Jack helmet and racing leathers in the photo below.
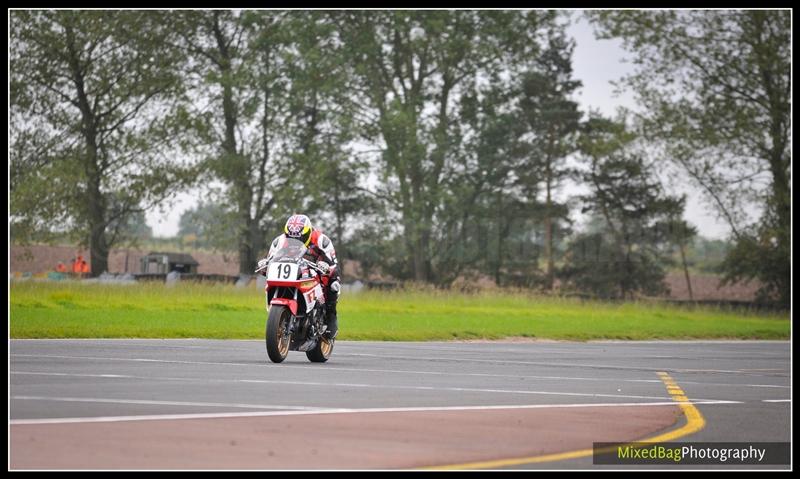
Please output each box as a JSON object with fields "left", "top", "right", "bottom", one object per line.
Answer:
{"left": 259, "top": 214, "right": 341, "bottom": 339}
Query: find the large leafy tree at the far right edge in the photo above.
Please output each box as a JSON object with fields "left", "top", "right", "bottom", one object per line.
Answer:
{"left": 590, "top": 10, "right": 792, "bottom": 305}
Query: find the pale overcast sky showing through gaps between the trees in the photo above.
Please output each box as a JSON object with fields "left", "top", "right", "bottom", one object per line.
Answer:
{"left": 147, "top": 15, "right": 729, "bottom": 238}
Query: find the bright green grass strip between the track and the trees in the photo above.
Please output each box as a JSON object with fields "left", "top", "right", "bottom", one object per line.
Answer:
{"left": 9, "top": 281, "right": 789, "bottom": 341}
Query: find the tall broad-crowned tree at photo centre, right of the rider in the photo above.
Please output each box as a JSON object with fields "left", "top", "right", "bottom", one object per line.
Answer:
{"left": 333, "top": 11, "right": 555, "bottom": 281}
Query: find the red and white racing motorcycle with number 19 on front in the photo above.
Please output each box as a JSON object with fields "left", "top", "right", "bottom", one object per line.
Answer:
{"left": 255, "top": 238, "right": 334, "bottom": 363}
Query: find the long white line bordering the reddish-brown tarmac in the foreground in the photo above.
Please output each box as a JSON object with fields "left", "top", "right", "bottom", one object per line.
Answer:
{"left": 9, "top": 401, "right": 735, "bottom": 426}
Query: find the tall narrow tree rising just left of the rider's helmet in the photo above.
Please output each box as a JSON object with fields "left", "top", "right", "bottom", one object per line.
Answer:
{"left": 173, "top": 10, "right": 272, "bottom": 274}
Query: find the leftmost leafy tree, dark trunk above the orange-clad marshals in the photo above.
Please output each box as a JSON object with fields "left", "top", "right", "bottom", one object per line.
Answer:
{"left": 9, "top": 10, "right": 192, "bottom": 276}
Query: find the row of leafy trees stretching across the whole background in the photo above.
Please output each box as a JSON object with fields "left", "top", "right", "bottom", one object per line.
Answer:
{"left": 9, "top": 10, "right": 780, "bottom": 301}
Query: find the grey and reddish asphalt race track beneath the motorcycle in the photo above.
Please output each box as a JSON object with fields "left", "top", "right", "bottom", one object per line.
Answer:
{"left": 9, "top": 340, "right": 791, "bottom": 469}
